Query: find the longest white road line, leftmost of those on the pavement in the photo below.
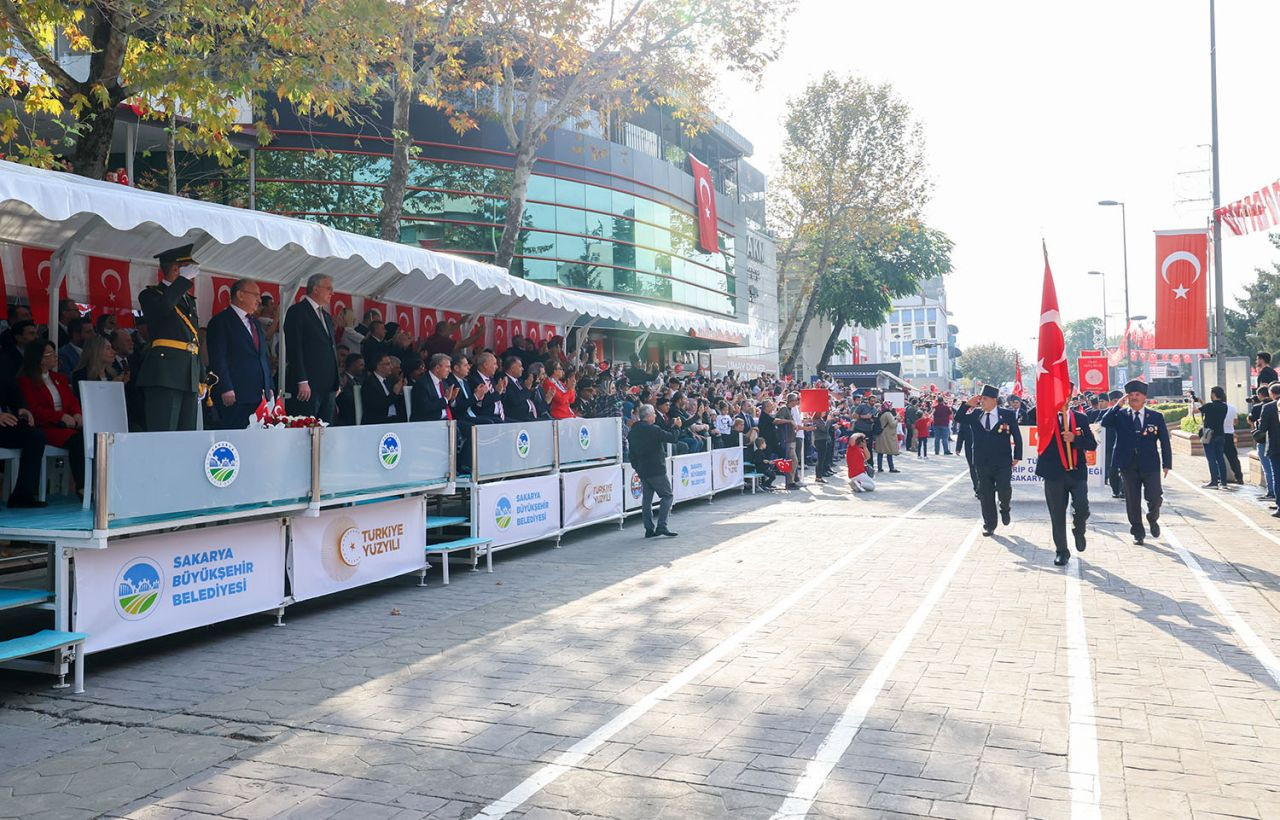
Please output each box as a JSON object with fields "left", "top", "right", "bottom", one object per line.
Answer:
{"left": 475, "top": 469, "right": 969, "bottom": 820}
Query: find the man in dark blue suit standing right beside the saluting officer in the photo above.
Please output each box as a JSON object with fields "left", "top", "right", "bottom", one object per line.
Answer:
{"left": 207, "top": 279, "right": 275, "bottom": 430}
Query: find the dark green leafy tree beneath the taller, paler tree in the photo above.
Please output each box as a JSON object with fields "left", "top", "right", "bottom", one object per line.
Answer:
{"left": 814, "top": 221, "right": 952, "bottom": 370}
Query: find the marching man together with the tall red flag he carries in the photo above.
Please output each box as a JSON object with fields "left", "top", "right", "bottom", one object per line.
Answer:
{"left": 1036, "top": 248, "right": 1098, "bottom": 567}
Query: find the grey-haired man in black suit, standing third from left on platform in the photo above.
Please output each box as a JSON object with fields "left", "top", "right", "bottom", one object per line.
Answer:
{"left": 284, "top": 274, "right": 337, "bottom": 422}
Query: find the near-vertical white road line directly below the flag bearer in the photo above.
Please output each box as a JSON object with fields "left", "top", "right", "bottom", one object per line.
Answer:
{"left": 1066, "top": 552, "right": 1102, "bottom": 820}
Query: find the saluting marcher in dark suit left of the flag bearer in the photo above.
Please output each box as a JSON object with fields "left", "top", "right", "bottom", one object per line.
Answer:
{"left": 963, "top": 384, "right": 1023, "bottom": 536}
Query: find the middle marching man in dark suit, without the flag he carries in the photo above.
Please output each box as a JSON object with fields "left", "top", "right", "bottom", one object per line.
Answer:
{"left": 1032, "top": 388, "right": 1098, "bottom": 567}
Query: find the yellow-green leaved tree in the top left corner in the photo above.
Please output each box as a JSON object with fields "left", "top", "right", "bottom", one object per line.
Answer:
{"left": 0, "top": 0, "right": 387, "bottom": 178}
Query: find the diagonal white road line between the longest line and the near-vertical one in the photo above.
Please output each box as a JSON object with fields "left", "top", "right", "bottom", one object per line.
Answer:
{"left": 773, "top": 524, "right": 978, "bottom": 820}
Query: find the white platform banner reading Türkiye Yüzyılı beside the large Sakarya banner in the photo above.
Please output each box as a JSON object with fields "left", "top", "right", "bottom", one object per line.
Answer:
{"left": 289, "top": 499, "right": 426, "bottom": 601}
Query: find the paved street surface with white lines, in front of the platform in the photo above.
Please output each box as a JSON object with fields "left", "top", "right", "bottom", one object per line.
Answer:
{"left": 0, "top": 457, "right": 1280, "bottom": 820}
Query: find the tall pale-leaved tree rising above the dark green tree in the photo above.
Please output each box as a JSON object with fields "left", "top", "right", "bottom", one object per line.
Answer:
{"left": 773, "top": 73, "right": 928, "bottom": 372}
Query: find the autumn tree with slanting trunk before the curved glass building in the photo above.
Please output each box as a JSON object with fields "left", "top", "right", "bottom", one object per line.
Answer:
{"left": 481, "top": 0, "right": 794, "bottom": 267}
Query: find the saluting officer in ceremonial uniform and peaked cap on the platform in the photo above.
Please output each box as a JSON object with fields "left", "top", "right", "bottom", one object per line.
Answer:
{"left": 137, "top": 244, "right": 202, "bottom": 432}
